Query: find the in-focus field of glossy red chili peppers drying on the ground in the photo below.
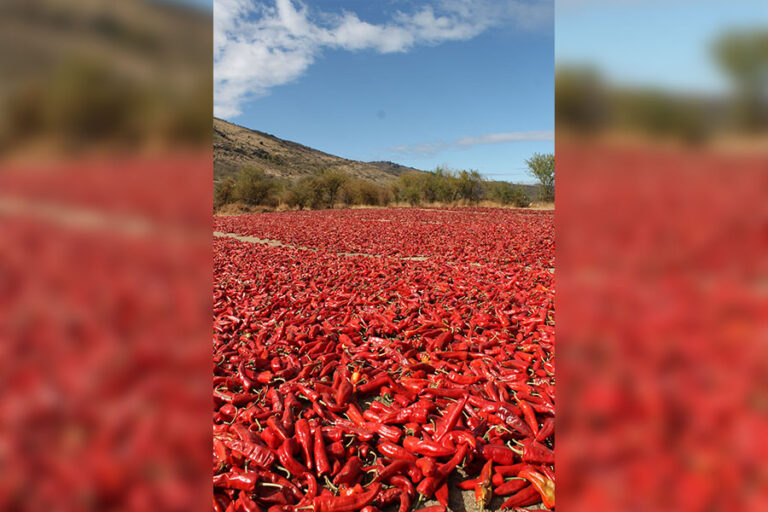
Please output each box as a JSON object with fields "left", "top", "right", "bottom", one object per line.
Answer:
{"left": 213, "top": 209, "right": 555, "bottom": 512}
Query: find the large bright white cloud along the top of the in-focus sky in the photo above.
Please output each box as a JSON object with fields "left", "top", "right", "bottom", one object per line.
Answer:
{"left": 213, "top": 0, "right": 553, "bottom": 118}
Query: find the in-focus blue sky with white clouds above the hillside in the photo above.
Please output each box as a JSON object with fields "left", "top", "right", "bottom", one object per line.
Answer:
{"left": 214, "top": 0, "right": 554, "bottom": 182}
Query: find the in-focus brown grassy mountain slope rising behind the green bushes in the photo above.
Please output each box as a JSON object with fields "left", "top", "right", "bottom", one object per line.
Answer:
{"left": 213, "top": 118, "right": 418, "bottom": 185}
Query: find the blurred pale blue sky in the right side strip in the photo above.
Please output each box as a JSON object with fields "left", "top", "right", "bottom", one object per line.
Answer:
{"left": 555, "top": 0, "right": 768, "bottom": 93}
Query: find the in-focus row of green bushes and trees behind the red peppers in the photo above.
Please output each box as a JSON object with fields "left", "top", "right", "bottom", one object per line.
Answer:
{"left": 214, "top": 153, "right": 554, "bottom": 210}
